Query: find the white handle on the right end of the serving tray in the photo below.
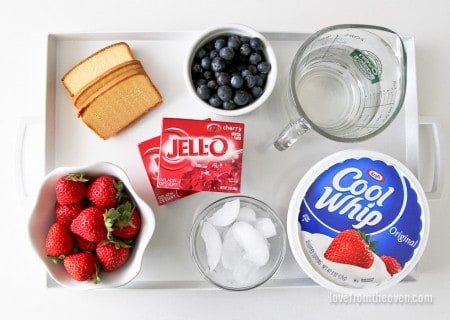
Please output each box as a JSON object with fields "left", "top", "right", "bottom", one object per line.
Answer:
{"left": 419, "top": 116, "right": 445, "bottom": 200}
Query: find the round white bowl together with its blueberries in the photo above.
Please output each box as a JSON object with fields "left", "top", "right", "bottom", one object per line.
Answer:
{"left": 185, "top": 24, "right": 277, "bottom": 116}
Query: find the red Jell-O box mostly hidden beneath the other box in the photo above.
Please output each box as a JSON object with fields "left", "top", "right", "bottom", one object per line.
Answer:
{"left": 138, "top": 136, "right": 195, "bottom": 206}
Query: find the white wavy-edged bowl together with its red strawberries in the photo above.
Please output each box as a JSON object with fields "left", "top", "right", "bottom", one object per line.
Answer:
{"left": 28, "top": 162, "right": 155, "bottom": 290}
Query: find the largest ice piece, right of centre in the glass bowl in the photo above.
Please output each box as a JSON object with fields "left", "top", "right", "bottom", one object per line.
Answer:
{"left": 230, "top": 221, "right": 269, "bottom": 267}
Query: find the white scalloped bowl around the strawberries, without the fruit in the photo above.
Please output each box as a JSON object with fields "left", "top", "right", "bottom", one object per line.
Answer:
{"left": 28, "top": 162, "right": 155, "bottom": 290}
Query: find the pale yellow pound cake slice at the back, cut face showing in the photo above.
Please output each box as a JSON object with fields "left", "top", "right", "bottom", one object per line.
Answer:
{"left": 61, "top": 42, "right": 134, "bottom": 96}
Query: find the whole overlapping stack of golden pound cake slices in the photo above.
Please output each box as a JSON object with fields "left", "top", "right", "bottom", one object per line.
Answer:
{"left": 61, "top": 42, "right": 162, "bottom": 140}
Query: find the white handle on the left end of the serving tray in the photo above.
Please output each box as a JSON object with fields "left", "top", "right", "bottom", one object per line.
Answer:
{"left": 15, "top": 115, "right": 45, "bottom": 201}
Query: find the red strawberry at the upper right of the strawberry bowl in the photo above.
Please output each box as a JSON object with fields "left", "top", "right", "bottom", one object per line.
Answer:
{"left": 86, "top": 175, "right": 123, "bottom": 209}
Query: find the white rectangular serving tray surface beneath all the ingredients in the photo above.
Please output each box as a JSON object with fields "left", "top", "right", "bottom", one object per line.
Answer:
{"left": 45, "top": 32, "right": 419, "bottom": 289}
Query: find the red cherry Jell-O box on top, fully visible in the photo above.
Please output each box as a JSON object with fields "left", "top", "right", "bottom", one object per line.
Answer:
{"left": 158, "top": 118, "right": 244, "bottom": 193}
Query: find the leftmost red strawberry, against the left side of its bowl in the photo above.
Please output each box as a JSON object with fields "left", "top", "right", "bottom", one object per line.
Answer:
{"left": 45, "top": 223, "right": 74, "bottom": 262}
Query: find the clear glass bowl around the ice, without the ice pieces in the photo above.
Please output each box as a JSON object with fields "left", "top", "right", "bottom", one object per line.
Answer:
{"left": 190, "top": 196, "right": 286, "bottom": 291}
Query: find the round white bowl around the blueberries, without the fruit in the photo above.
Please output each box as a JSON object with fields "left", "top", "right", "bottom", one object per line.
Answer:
{"left": 184, "top": 23, "right": 278, "bottom": 116}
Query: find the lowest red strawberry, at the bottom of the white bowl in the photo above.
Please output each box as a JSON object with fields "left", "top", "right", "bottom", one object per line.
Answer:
{"left": 63, "top": 252, "right": 100, "bottom": 283}
